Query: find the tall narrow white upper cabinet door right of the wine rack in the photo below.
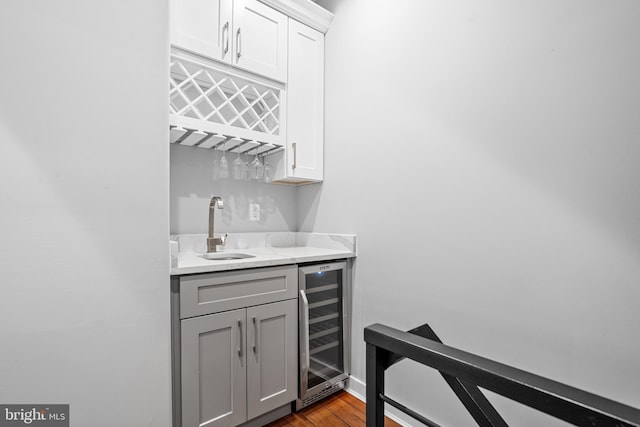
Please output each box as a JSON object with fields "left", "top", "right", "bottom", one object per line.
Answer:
{"left": 286, "top": 19, "right": 324, "bottom": 181}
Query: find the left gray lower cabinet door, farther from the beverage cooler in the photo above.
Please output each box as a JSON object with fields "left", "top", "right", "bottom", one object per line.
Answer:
{"left": 181, "top": 309, "right": 247, "bottom": 427}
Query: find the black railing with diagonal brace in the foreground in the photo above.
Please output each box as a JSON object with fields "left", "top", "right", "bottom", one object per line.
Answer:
{"left": 364, "top": 324, "right": 640, "bottom": 427}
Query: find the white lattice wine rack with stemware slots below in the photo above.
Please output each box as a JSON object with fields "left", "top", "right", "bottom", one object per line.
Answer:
{"left": 169, "top": 50, "right": 284, "bottom": 155}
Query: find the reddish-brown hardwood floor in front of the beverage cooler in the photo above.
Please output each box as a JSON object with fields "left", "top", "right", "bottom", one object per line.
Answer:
{"left": 267, "top": 391, "right": 401, "bottom": 427}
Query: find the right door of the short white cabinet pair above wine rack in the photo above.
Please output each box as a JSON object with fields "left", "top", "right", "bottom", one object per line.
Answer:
{"left": 232, "top": 0, "right": 288, "bottom": 82}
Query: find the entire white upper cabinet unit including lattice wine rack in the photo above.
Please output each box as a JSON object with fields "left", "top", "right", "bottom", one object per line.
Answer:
{"left": 169, "top": 0, "right": 333, "bottom": 184}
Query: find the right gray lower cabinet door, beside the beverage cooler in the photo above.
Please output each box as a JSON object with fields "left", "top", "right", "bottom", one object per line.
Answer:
{"left": 247, "top": 300, "right": 298, "bottom": 419}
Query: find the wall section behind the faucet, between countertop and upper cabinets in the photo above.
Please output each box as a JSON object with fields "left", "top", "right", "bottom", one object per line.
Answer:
{"left": 171, "top": 145, "right": 298, "bottom": 235}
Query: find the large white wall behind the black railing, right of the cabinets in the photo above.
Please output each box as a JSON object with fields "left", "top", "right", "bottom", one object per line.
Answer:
{"left": 308, "top": 0, "right": 640, "bottom": 425}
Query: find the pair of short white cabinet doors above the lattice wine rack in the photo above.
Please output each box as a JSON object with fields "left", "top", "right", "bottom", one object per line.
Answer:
{"left": 171, "top": 0, "right": 288, "bottom": 82}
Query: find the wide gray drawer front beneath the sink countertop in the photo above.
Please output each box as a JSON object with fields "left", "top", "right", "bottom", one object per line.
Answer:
{"left": 180, "top": 265, "right": 298, "bottom": 319}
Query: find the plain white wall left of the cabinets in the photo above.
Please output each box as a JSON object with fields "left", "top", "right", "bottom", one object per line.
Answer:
{"left": 0, "top": 0, "right": 171, "bottom": 427}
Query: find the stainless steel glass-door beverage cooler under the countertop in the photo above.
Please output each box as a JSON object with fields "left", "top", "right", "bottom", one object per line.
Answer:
{"left": 296, "top": 261, "right": 351, "bottom": 409}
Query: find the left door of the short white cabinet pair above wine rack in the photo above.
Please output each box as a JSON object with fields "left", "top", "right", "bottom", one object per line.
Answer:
{"left": 171, "top": 0, "right": 233, "bottom": 61}
